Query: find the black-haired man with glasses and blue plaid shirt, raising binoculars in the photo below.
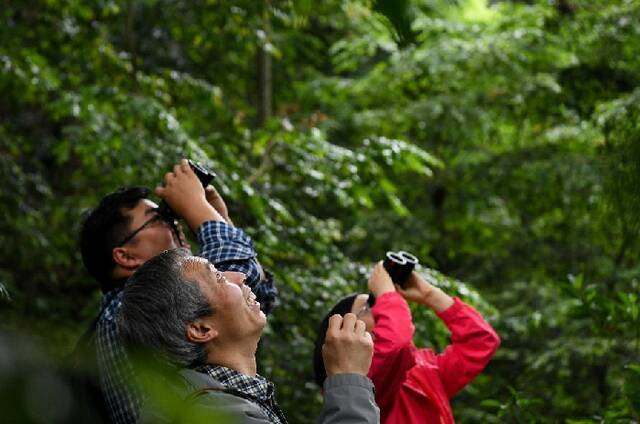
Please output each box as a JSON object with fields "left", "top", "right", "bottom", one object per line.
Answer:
{"left": 80, "top": 160, "right": 277, "bottom": 424}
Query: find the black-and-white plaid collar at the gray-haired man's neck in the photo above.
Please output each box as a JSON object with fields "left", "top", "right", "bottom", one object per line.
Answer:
{"left": 196, "top": 365, "right": 287, "bottom": 424}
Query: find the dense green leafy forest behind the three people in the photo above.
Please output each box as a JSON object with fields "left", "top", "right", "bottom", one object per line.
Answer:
{"left": 0, "top": 0, "right": 640, "bottom": 423}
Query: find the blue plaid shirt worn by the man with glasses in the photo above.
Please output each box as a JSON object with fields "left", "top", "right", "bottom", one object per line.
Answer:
{"left": 96, "top": 221, "right": 278, "bottom": 424}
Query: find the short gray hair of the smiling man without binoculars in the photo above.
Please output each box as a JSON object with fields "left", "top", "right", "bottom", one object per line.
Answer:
{"left": 116, "top": 249, "right": 214, "bottom": 367}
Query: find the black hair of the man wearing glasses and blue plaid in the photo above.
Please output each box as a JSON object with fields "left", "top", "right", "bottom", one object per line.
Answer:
{"left": 80, "top": 187, "right": 149, "bottom": 293}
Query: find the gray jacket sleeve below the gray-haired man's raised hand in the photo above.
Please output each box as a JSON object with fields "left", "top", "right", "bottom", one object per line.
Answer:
{"left": 318, "top": 374, "right": 380, "bottom": 424}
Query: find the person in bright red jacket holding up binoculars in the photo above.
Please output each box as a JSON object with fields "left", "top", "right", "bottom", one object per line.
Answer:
{"left": 314, "top": 262, "right": 500, "bottom": 424}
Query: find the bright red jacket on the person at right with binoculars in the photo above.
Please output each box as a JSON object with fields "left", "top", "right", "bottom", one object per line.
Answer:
{"left": 369, "top": 292, "right": 500, "bottom": 424}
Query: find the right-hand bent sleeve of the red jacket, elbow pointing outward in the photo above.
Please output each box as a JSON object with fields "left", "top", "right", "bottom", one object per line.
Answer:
{"left": 437, "top": 298, "right": 500, "bottom": 398}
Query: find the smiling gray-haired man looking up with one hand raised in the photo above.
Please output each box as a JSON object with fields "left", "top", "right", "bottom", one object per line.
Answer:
{"left": 117, "top": 249, "right": 379, "bottom": 424}
